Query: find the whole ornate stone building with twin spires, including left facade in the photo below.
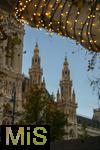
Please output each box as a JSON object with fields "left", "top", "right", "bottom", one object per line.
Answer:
{"left": 0, "top": 10, "right": 100, "bottom": 139}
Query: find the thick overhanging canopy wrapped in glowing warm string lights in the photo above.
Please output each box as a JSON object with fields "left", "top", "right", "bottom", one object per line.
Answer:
{"left": 0, "top": 0, "right": 100, "bottom": 52}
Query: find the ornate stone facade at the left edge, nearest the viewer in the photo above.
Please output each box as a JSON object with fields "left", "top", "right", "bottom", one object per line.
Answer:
{"left": 0, "top": 10, "right": 24, "bottom": 124}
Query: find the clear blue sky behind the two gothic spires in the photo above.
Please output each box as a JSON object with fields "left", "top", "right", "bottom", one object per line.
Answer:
{"left": 22, "top": 26, "right": 97, "bottom": 117}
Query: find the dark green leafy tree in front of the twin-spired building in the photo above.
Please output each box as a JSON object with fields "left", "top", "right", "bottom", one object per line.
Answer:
{"left": 20, "top": 86, "right": 66, "bottom": 141}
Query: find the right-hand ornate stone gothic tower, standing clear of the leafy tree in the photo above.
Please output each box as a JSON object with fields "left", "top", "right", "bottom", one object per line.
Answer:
{"left": 57, "top": 57, "right": 77, "bottom": 138}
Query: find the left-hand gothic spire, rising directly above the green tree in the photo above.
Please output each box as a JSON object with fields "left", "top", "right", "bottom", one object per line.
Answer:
{"left": 29, "top": 42, "right": 43, "bottom": 87}
